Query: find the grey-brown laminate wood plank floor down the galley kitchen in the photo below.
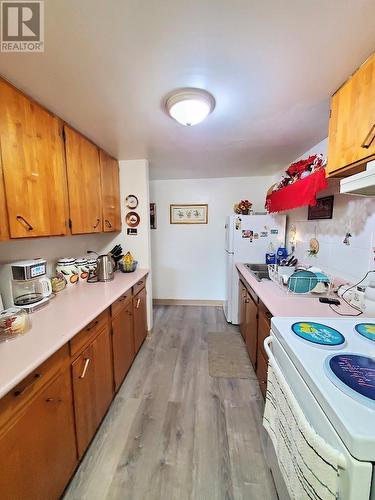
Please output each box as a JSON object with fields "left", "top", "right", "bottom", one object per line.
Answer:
{"left": 64, "top": 306, "right": 277, "bottom": 500}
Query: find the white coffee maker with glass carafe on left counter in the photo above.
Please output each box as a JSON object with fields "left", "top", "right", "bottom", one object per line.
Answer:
{"left": 0, "top": 259, "right": 52, "bottom": 313}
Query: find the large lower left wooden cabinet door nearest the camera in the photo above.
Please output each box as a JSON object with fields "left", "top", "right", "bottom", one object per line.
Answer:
{"left": 0, "top": 369, "right": 77, "bottom": 500}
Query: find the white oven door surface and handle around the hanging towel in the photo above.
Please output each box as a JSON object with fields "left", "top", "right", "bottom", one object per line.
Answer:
{"left": 265, "top": 331, "right": 375, "bottom": 500}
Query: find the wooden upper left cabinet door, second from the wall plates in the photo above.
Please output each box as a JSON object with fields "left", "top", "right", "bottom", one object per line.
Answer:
{"left": 64, "top": 125, "right": 102, "bottom": 234}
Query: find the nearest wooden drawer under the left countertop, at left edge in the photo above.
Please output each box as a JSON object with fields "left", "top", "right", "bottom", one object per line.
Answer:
{"left": 0, "top": 344, "right": 69, "bottom": 434}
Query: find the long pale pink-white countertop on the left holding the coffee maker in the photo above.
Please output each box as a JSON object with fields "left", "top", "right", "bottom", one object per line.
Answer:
{"left": 0, "top": 269, "right": 148, "bottom": 397}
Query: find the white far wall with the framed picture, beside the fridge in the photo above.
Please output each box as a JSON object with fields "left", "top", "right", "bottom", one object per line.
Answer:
{"left": 150, "top": 176, "right": 272, "bottom": 300}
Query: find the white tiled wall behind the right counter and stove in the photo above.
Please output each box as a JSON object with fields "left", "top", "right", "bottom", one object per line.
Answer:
{"left": 287, "top": 139, "right": 375, "bottom": 282}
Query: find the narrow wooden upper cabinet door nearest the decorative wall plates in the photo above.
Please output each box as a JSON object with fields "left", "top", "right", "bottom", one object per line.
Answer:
{"left": 100, "top": 150, "right": 121, "bottom": 232}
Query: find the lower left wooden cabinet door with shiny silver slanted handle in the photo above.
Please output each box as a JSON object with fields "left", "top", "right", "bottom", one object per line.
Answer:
{"left": 72, "top": 329, "right": 113, "bottom": 457}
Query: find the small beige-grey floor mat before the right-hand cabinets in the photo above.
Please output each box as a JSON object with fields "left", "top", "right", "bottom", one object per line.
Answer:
{"left": 208, "top": 332, "right": 256, "bottom": 378}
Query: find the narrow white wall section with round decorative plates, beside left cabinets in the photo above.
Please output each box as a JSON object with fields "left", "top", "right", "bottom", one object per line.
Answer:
{"left": 105, "top": 160, "right": 152, "bottom": 330}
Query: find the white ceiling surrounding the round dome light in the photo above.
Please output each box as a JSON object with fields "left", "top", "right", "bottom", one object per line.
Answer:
{"left": 0, "top": 0, "right": 375, "bottom": 179}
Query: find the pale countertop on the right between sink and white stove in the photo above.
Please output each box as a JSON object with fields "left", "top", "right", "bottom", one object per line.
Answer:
{"left": 236, "top": 264, "right": 355, "bottom": 318}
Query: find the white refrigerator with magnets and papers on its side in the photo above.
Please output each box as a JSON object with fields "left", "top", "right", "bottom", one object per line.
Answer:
{"left": 224, "top": 215, "right": 286, "bottom": 325}
